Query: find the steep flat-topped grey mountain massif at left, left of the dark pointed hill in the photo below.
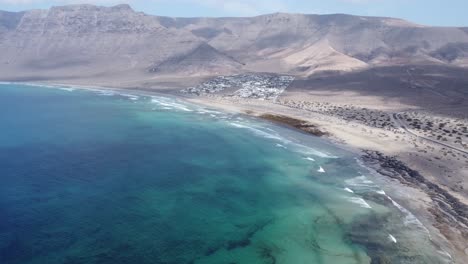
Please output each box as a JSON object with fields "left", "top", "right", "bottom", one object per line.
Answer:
{"left": 0, "top": 5, "right": 201, "bottom": 78}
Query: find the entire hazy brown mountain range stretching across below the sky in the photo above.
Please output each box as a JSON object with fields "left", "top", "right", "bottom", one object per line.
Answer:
{"left": 0, "top": 5, "right": 468, "bottom": 80}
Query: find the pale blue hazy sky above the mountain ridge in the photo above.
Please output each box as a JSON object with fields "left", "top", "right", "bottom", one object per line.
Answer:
{"left": 0, "top": 0, "right": 468, "bottom": 26}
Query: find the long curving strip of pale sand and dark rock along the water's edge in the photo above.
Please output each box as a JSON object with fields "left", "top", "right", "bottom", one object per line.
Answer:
{"left": 4, "top": 82, "right": 468, "bottom": 263}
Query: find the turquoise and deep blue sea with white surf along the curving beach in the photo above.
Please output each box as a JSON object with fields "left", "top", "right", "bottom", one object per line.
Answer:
{"left": 0, "top": 84, "right": 448, "bottom": 264}
